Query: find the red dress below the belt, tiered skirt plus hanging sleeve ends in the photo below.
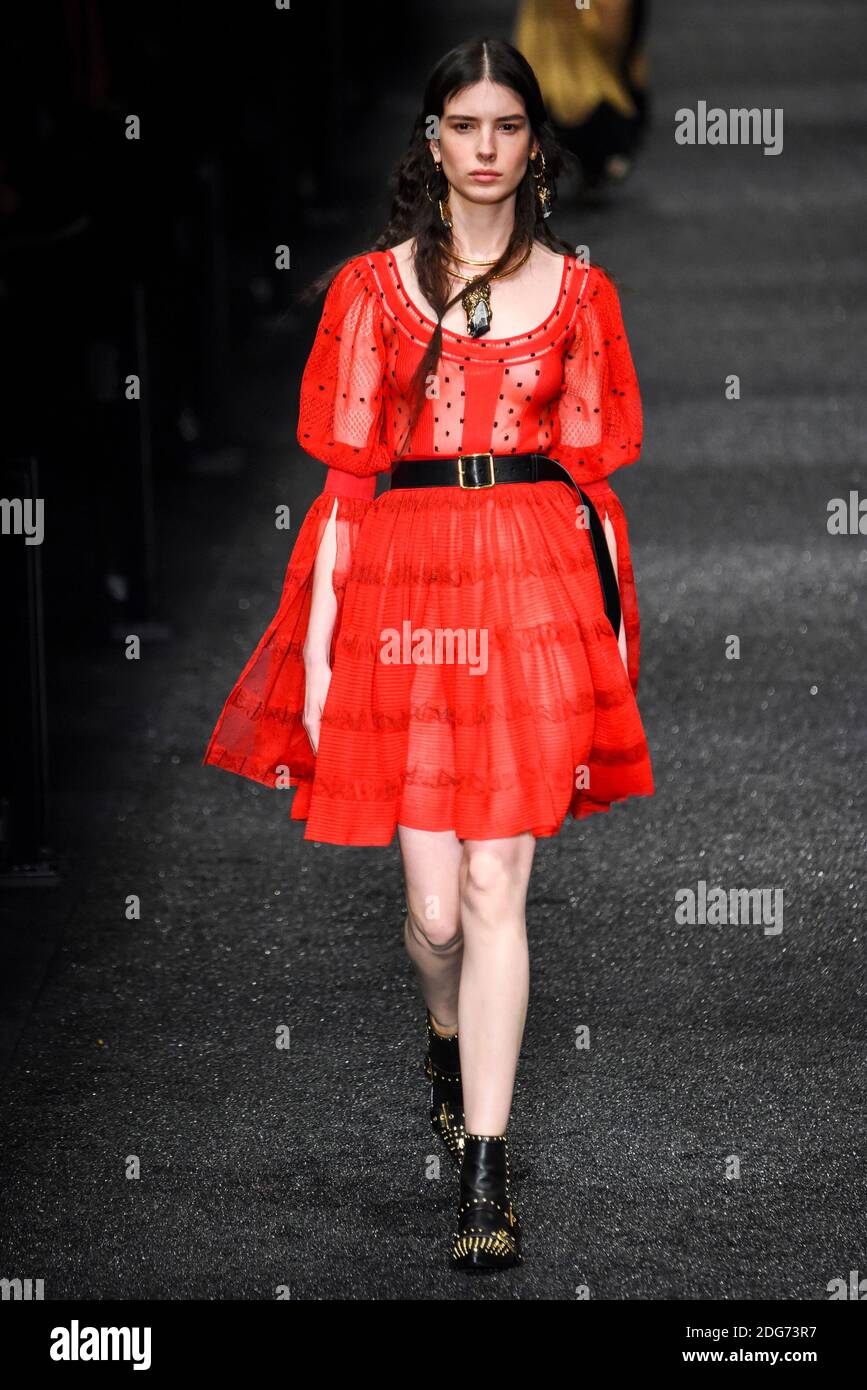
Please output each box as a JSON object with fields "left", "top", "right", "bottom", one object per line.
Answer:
{"left": 203, "top": 482, "right": 654, "bottom": 845}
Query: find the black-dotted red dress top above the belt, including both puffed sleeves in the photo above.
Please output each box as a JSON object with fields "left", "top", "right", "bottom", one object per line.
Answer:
{"left": 297, "top": 252, "right": 642, "bottom": 498}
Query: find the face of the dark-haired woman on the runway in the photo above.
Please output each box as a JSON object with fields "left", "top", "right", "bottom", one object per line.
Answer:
{"left": 428, "top": 81, "right": 538, "bottom": 203}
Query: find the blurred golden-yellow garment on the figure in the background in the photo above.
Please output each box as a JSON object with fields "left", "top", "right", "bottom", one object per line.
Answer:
{"left": 514, "top": 0, "right": 636, "bottom": 125}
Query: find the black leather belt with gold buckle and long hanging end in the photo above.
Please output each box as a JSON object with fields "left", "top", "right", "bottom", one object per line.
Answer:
{"left": 390, "top": 453, "right": 620, "bottom": 637}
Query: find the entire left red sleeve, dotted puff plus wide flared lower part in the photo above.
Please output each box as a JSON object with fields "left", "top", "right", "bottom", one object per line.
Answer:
{"left": 203, "top": 257, "right": 390, "bottom": 789}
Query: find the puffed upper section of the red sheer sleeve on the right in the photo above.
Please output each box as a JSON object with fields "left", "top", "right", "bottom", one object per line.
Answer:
{"left": 552, "top": 265, "right": 643, "bottom": 492}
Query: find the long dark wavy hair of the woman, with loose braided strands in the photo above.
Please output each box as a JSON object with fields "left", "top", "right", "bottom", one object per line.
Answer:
{"left": 299, "top": 38, "right": 604, "bottom": 452}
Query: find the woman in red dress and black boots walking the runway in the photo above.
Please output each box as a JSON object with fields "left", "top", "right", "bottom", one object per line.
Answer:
{"left": 203, "top": 39, "right": 654, "bottom": 1269}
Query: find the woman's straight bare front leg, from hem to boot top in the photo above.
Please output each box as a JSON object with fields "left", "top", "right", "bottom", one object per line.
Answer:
{"left": 459, "top": 833, "right": 536, "bottom": 1134}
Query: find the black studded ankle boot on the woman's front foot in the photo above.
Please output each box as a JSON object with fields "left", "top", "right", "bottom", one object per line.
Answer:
{"left": 452, "top": 1131, "right": 524, "bottom": 1273}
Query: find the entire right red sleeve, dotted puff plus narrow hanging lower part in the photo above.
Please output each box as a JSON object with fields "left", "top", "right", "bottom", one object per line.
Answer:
{"left": 550, "top": 265, "right": 643, "bottom": 691}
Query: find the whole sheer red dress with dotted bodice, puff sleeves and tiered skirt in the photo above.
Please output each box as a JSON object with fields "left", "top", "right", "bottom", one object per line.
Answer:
{"left": 203, "top": 250, "right": 654, "bottom": 845}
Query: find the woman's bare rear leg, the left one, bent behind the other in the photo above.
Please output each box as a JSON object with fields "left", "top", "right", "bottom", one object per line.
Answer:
{"left": 397, "top": 826, "right": 463, "bottom": 1034}
